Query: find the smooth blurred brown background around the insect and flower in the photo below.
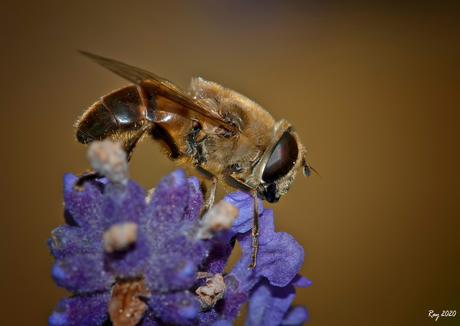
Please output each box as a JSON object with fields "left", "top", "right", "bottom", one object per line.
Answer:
{"left": 0, "top": 1, "right": 460, "bottom": 326}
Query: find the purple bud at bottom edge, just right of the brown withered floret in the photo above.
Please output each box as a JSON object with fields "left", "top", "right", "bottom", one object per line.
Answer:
{"left": 148, "top": 291, "right": 200, "bottom": 325}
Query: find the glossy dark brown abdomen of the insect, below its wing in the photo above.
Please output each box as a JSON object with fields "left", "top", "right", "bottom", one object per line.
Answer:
{"left": 75, "top": 85, "right": 157, "bottom": 144}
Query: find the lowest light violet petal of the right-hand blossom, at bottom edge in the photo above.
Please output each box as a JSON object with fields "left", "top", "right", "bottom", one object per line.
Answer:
{"left": 245, "top": 278, "right": 295, "bottom": 326}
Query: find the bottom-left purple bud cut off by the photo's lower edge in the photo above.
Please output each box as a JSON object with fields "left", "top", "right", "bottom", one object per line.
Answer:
{"left": 48, "top": 292, "right": 110, "bottom": 326}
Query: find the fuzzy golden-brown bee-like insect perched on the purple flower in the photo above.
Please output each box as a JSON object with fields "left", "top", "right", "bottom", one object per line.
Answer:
{"left": 75, "top": 52, "right": 312, "bottom": 268}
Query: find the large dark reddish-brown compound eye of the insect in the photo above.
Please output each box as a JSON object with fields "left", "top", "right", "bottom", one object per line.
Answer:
{"left": 262, "top": 131, "right": 299, "bottom": 182}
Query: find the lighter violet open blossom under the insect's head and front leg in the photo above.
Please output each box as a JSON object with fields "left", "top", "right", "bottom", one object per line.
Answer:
{"left": 198, "top": 192, "right": 311, "bottom": 326}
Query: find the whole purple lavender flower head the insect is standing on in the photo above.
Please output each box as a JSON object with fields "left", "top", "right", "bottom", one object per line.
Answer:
{"left": 48, "top": 141, "right": 310, "bottom": 326}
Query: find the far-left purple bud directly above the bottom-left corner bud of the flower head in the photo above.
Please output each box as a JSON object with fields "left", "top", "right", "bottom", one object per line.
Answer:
{"left": 51, "top": 254, "right": 113, "bottom": 293}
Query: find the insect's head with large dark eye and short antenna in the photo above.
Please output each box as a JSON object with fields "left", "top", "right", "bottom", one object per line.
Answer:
{"left": 255, "top": 120, "right": 310, "bottom": 203}
